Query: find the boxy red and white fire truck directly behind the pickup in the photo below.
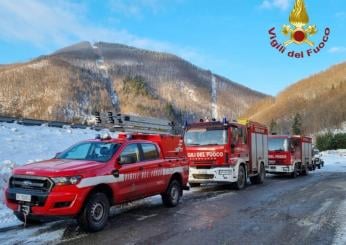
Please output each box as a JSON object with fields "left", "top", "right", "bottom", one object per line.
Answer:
{"left": 184, "top": 119, "right": 268, "bottom": 189}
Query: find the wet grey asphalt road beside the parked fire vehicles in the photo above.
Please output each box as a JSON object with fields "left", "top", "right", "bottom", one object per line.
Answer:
{"left": 63, "top": 172, "right": 346, "bottom": 245}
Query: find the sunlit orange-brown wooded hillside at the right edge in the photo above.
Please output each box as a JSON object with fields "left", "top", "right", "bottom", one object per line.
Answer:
{"left": 245, "top": 63, "right": 346, "bottom": 134}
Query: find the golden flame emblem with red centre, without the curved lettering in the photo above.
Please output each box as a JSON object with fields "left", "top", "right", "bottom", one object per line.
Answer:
{"left": 282, "top": 0, "right": 317, "bottom": 46}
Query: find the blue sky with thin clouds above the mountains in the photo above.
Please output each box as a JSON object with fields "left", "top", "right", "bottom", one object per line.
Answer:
{"left": 0, "top": 0, "right": 346, "bottom": 95}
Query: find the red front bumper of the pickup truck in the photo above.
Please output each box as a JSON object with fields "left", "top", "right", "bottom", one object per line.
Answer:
{"left": 5, "top": 186, "right": 89, "bottom": 216}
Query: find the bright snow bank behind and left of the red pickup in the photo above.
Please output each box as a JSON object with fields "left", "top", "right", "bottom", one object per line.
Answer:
{"left": 0, "top": 123, "right": 110, "bottom": 231}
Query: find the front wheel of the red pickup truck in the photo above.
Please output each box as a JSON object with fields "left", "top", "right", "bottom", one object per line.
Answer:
{"left": 78, "top": 192, "right": 110, "bottom": 232}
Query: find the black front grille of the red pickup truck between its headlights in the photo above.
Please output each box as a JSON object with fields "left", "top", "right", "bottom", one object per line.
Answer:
{"left": 9, "top": 175, "right": 54, "bottom": 193}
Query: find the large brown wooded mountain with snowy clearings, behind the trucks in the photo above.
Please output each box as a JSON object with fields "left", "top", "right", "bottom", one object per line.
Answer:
{"left": 0, "top": 42, "right": 267, "bottom": 122}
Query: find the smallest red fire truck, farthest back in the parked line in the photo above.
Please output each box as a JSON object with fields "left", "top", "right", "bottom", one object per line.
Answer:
{"left": 266, "top": 135, "right": 312, "bottom": 178}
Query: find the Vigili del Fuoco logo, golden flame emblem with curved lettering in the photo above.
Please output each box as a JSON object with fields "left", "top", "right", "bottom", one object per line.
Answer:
{"left": 268, "top": 0, "right": 330, "bottom": 59}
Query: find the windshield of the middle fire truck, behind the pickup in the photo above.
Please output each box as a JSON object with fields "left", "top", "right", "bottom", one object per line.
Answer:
{"left": 184, "top": 129, "right": 227, "bottom": 146}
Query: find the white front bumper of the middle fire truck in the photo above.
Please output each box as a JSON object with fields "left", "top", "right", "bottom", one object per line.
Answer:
{"left": 189, "top": 167, "right": 238, "bottom": 183}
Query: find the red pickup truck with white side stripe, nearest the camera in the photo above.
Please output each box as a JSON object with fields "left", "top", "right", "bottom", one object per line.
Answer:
{"left": 5, "top": 134, "right": 188, "bottom": 231}
